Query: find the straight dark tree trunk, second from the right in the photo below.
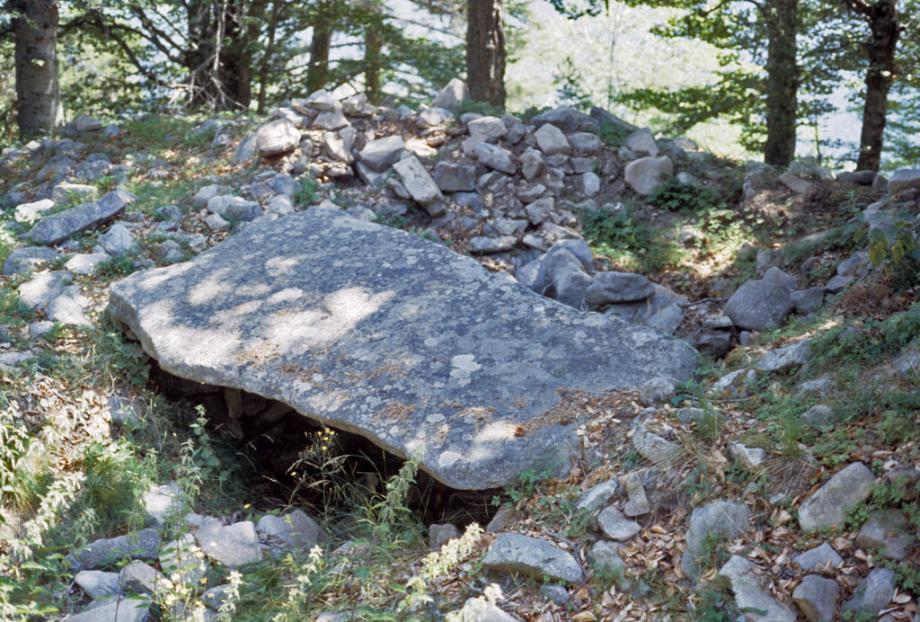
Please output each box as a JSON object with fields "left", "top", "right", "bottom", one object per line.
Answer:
{"left": 764, "top": 0, "right": 799, "bottom": 166}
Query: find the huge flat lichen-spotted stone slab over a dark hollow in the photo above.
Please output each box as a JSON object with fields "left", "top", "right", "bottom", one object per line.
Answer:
{"left": 110, "top": 208, "right": 696, "bottom": 490}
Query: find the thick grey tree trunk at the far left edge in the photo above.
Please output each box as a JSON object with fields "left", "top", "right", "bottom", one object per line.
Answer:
{"left": 11, "top": 0, "right": 64, "bottom": 138}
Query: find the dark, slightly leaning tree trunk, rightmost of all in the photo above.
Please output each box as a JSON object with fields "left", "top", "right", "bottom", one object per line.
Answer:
{"left": 856, "top": 0, "right": 901, "bottom": 171}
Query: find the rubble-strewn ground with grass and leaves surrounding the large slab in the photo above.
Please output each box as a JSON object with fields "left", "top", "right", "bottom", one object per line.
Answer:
{"left": 0, "top": 82, "right": 920, "bottom": 622}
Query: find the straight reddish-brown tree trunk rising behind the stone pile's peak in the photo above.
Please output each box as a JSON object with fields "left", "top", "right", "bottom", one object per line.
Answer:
{"left": 466, "top": 0, "right": 505, "bottom": 108}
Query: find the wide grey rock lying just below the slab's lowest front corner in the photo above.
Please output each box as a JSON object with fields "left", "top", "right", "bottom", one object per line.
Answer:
{"left": 482, "top": 533, "right": 583, "bottom": 583}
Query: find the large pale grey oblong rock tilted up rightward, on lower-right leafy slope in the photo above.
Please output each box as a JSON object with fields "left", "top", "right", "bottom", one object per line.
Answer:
{"left": 799, "top": 462, "right": 875, "bottom": 531}
